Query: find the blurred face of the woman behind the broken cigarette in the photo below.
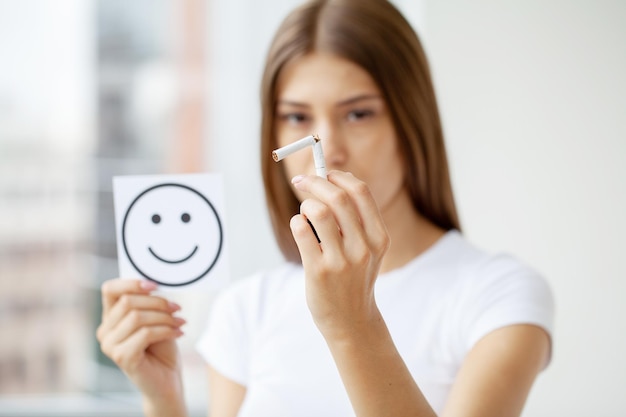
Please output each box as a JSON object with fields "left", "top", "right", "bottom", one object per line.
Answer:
{"left": 275, "top": 53, "right": 404, "bottom": 210}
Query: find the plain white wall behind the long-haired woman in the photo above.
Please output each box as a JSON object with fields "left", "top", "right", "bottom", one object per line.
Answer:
{"left": 207, "top": 0, "right": 626, "bottom": 417}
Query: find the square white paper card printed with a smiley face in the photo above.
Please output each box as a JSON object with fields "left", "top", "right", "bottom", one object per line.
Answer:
{"left": 113, "top": 174, "right": 228, "bottom": 289}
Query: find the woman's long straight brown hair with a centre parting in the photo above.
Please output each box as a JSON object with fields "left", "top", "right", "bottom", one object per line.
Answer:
{"left": 261, "top": 0, "right": 460, "bottom": 263}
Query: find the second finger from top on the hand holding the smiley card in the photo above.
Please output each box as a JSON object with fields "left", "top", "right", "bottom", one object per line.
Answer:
{"left": 97, "top": 294, "right": 180, "bottom": 338}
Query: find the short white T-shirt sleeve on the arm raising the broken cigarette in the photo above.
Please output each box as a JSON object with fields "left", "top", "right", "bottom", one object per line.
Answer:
{"left": 462, "top": 255, "right": 554, "bottom": 360}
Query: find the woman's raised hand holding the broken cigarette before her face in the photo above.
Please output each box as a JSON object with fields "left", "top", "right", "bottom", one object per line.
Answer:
{"left": 290, "top": 171, "right": 389, "bottom": 340}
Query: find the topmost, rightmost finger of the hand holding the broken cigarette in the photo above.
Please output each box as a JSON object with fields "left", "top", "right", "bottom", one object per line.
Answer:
{"left": 328, "top": 171, "right": 389, "bottom": 252}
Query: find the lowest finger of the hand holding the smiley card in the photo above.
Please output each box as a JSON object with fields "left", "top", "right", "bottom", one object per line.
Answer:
{"left": 105, "top": 326, "right": 183, "bottom": 370}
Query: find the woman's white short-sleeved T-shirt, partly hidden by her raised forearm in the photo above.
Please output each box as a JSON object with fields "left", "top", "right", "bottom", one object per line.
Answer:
{"left": 197, "top": 231, "right": 554, "bottom": 417}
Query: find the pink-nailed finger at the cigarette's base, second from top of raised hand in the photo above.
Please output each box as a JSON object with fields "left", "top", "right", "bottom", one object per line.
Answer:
{"left": 292, "top": 176, "right": 364, "bottom": 239}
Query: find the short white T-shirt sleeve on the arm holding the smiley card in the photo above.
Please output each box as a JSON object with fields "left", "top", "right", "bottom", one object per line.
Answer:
{"left": 196, "top": 283, "right": 250, "bottom": 385}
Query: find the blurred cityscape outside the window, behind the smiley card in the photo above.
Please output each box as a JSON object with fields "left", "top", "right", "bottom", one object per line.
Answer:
{"left": 0, "top": 0, "right": 206, "bottom": 404}
